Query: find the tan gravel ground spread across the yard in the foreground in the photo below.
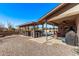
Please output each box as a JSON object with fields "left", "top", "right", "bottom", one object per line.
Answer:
{"left": 0, "top": 35, "right": 76, "bottom": 56}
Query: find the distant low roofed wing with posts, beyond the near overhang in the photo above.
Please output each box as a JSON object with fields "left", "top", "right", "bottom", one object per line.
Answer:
{"left": 19, "top": 22, "right": 43, "bottom": 38}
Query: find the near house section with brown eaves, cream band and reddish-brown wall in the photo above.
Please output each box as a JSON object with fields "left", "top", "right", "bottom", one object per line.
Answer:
{"left": 39, "top": 3, "right": 79, "bottom": 37}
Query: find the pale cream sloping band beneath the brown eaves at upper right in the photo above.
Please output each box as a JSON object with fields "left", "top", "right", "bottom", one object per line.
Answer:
{"left": 48, "top": 4, "right": 79, "bottom": 23}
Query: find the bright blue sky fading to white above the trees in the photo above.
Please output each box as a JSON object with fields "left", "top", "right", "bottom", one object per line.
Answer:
{"left": 0, "top": 3, "right": 59, "bottom": 27}
